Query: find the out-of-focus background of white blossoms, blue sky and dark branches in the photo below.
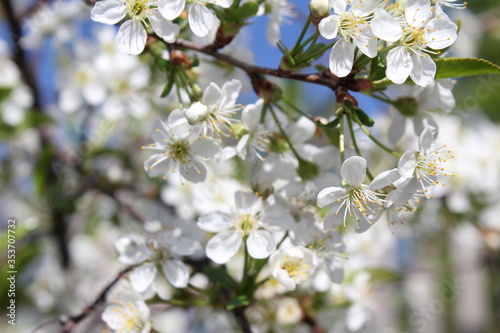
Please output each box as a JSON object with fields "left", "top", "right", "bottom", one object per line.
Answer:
{"left": 0, "top": 0, "right": 500, "bottom": 333}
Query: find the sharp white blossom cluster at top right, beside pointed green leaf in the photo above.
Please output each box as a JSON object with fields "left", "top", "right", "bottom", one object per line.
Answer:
{"left": 318, "top": 0, "right": 458, "bottom": 87}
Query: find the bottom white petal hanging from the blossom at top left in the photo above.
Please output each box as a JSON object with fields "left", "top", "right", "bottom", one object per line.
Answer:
{"left": 116, "top": 20, "right": 147, "bottom": 55}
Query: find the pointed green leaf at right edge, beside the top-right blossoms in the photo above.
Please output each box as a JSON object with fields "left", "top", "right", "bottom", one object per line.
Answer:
{"left": 435, "top": 58, "right": 500, "bottom": 79}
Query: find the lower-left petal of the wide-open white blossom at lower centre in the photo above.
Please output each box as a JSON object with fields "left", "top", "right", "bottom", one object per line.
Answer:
{"left": 206, "top": 230, "right": 242, "bottom": 264}
